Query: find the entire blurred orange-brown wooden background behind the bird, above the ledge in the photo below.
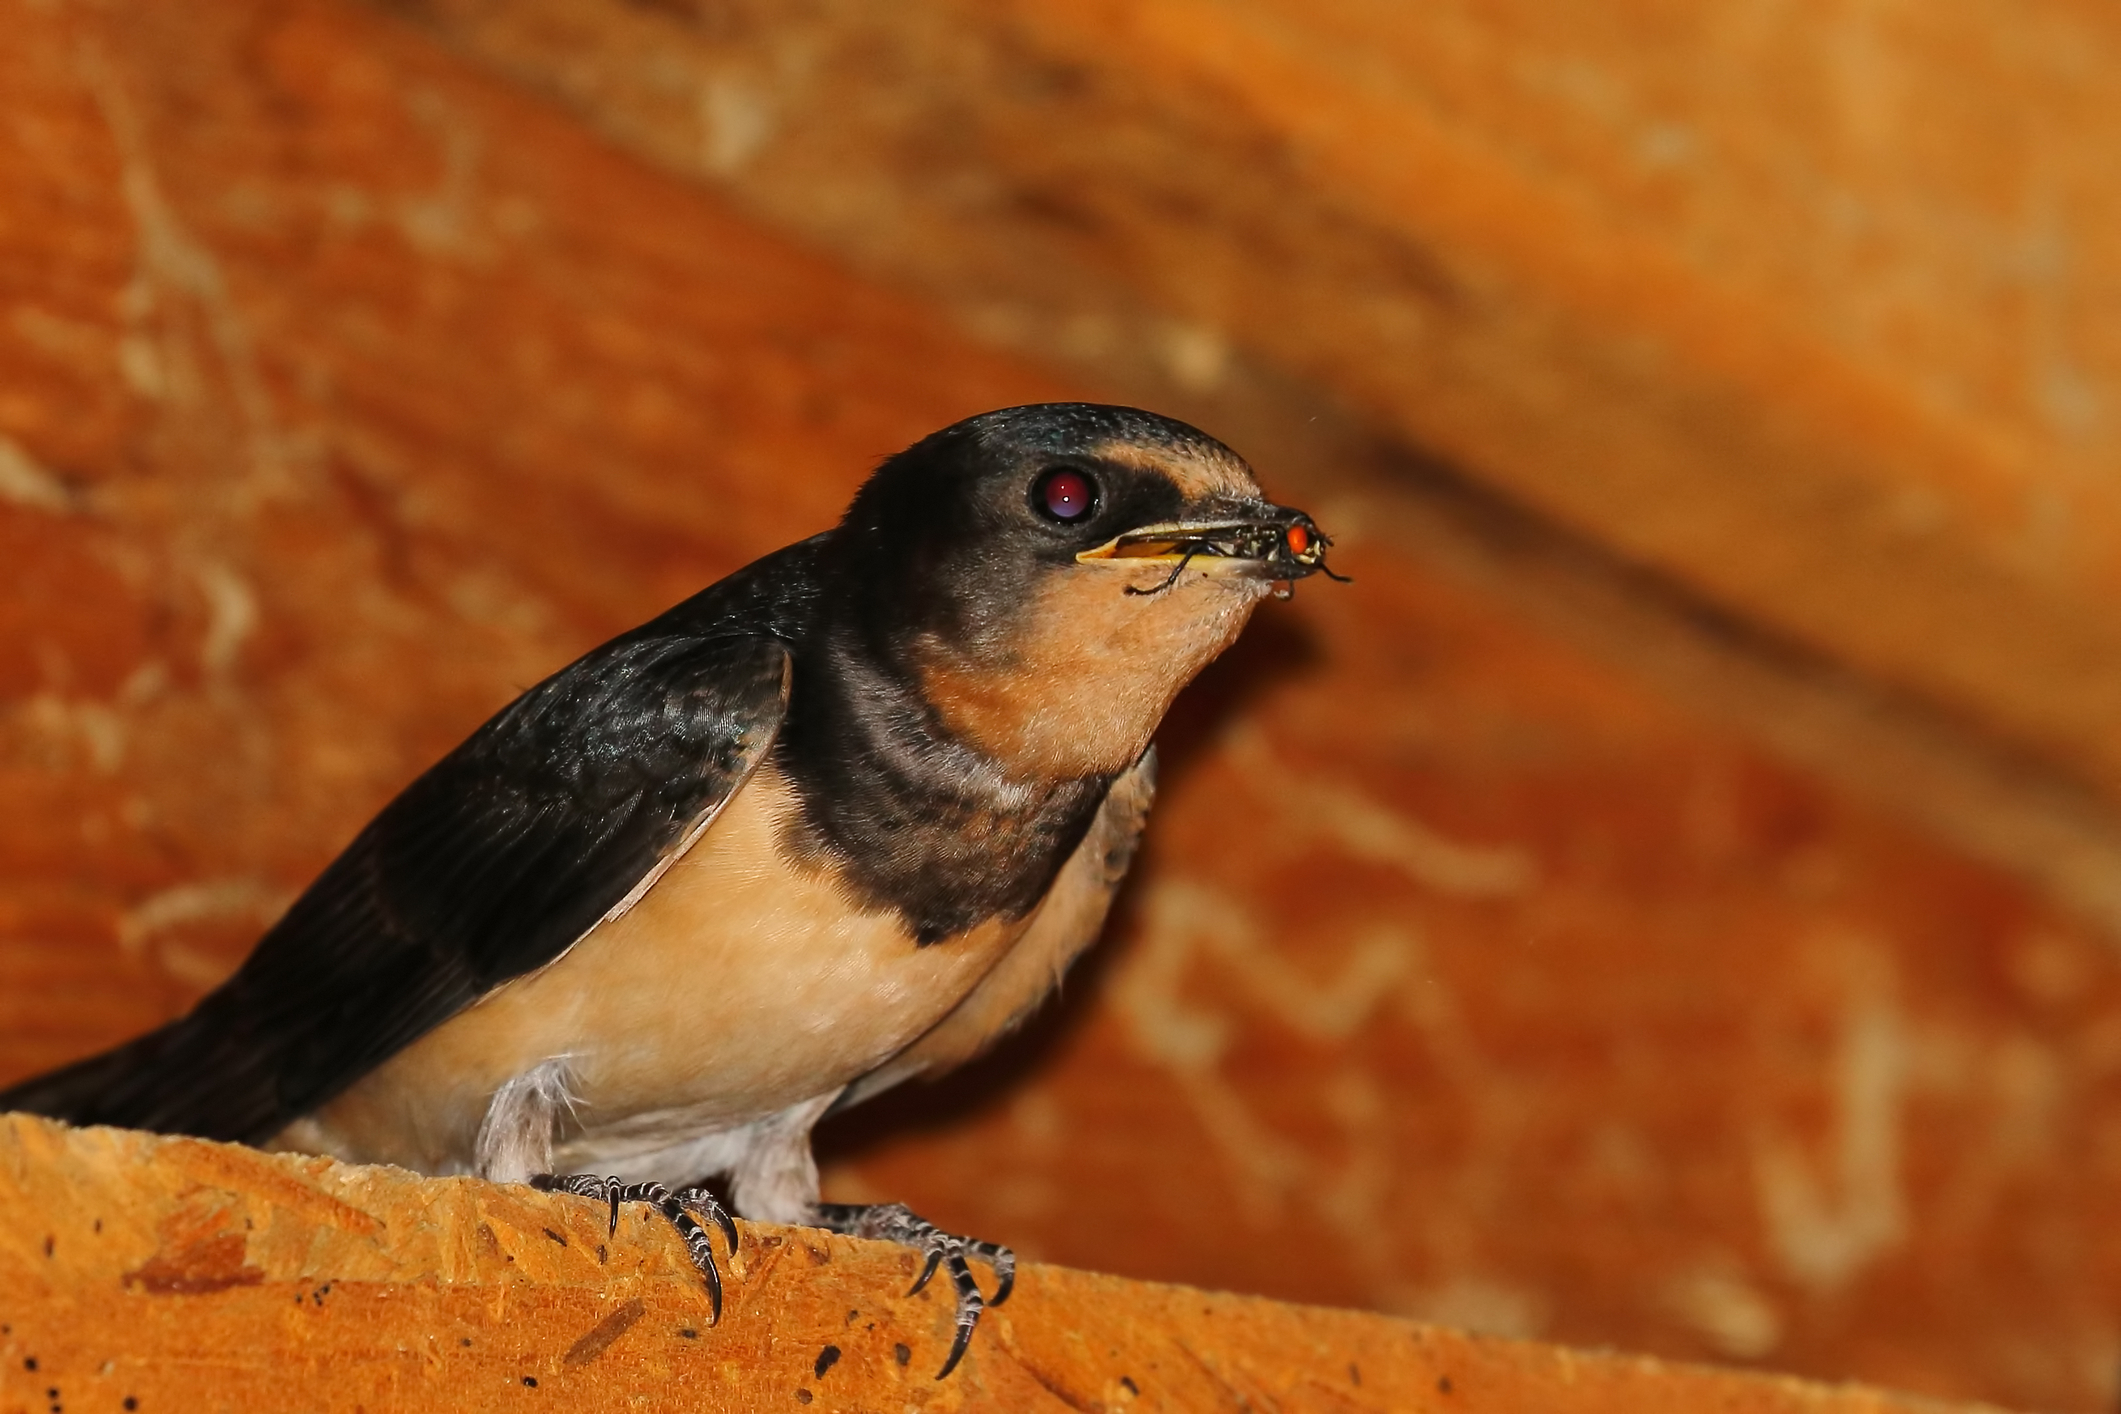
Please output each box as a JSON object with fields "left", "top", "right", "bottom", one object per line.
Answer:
{"left": 0, "top": 0, "right": 2121, "bottom": 1410}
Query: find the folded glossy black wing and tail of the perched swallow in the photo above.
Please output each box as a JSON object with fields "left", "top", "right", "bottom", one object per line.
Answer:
{"left": 0, "top": 631, "right": 789, "bottom": 1141}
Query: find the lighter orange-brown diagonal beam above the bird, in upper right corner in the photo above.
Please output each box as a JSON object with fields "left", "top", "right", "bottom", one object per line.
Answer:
{"left": 390, "top": 0, "right": 2121, "bottom": 793}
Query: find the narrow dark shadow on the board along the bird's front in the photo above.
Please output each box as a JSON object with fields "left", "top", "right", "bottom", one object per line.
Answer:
{"left": 814, "top": 610, "right": 1332, "bottom": 1164}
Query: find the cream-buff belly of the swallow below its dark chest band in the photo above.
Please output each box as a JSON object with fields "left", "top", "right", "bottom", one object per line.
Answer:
{"left": 292, "top": 765, "right": 1029, "bottom": 1170}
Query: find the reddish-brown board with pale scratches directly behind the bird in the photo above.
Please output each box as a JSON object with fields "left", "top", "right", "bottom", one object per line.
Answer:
{"left": 12, "top": 0, "right": 2121, "bottom": 1412}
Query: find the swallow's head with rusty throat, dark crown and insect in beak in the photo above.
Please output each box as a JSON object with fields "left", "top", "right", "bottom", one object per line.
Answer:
{"left": 829, "top": 403, "right": 1328, "bottom": 778}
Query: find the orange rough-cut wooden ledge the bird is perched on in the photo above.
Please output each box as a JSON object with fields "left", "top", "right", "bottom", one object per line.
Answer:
{"left": 0, "top": 1115, "right": 1985, "bottom": 1414}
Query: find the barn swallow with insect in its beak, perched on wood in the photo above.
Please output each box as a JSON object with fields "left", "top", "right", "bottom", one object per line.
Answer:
{"left": 0, "top": 403, "right": 1330, "bottom": 1378}
